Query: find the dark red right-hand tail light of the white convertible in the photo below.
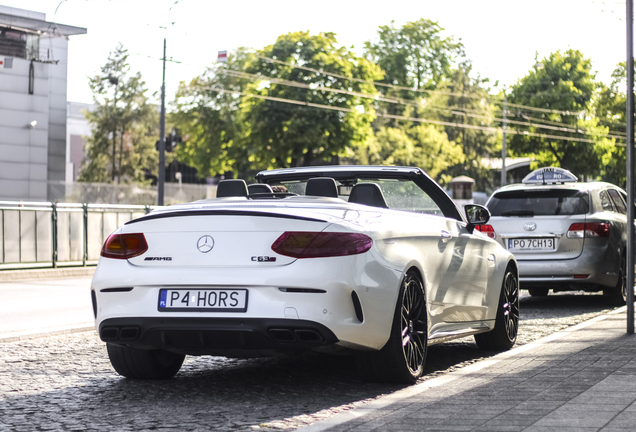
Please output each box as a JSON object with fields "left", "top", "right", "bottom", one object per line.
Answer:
{"left": 272, "top": 231, "right": 373, "bottom": 258}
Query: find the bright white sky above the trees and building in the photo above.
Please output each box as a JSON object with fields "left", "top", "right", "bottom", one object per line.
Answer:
{"left": 0, "top": 0, "right": 626, "bottom": 102}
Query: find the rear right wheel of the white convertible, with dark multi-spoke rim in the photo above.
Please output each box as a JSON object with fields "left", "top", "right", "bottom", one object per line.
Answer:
{"left": 356, "top": 271, "right": 428, "bottom": 384}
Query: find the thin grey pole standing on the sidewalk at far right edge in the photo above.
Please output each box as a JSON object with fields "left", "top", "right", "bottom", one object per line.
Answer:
{"left": 625, "top": 0, "right": 634, "bottom": 335}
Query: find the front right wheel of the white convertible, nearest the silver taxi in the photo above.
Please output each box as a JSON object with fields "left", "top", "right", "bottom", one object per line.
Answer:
{"left": 475, "top": 267, "right": 519, "bottom": 351}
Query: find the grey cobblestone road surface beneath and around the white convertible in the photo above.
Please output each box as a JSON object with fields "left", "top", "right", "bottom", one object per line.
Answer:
{"left": 0, "top": 294, "right": 614, "bottom": 431}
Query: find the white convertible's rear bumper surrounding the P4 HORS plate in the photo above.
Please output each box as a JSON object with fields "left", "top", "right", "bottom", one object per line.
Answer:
{"left": 92, "top": 254, "right": 401, "bottom": 356}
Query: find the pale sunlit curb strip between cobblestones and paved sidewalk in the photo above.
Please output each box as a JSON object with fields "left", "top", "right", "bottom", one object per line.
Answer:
{"left": 296, "top": 306, "right": 627, "bottom": 432}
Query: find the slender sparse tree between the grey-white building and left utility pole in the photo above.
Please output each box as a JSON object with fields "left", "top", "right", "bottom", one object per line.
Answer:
{"left": 79, "top": 44, "right": 158, "bottom": 183}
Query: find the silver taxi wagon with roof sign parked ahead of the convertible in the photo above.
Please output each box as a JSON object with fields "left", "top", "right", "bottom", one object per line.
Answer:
{"left": 478, "top": 167, "right": 627, "bottom": 301}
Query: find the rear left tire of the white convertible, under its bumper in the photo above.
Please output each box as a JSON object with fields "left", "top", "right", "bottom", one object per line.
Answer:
{"left": 106, "top": 343, "right": 185, "bottom": 379}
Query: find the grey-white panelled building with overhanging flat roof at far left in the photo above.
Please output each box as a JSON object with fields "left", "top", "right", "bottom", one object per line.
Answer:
{"left": 0, "top": 6, "right": 86, "bottom": 201}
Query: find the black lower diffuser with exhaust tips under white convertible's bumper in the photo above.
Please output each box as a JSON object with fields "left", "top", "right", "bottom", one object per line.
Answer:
{"left": 99, "top": 317, "right": 338, "bottom": 356}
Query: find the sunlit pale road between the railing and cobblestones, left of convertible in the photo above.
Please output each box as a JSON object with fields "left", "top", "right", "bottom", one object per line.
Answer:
{"left": 0, "top": 277, "right": 93, "bottom": 335}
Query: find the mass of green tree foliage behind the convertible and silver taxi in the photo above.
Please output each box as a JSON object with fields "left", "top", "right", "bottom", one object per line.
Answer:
{"left": 165, "top": 24, "right": 624, "bottom": 190}
